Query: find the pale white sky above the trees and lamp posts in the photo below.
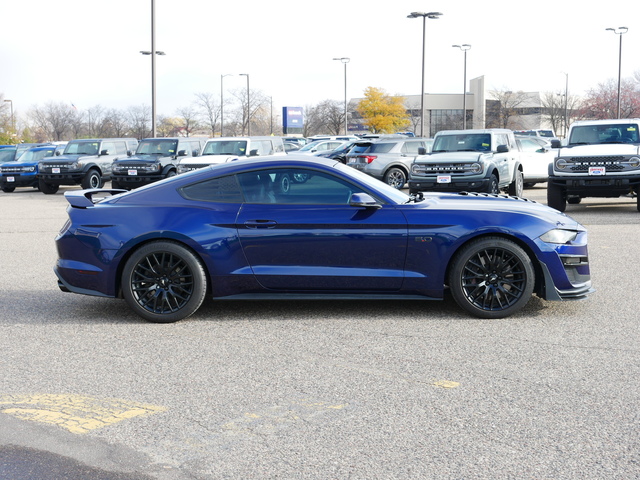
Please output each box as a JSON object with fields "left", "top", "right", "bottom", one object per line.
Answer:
{"left": 0, "top": 0, "right": 640, "bottom": 116}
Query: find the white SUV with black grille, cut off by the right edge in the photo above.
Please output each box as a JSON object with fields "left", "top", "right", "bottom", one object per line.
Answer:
{"left": 547, "top": 118, "right": 640, "bottom": 212}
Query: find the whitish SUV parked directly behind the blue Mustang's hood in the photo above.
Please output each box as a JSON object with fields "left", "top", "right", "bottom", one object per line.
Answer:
{"left": 409, "top": 129, "right": 524, "bottom": 197}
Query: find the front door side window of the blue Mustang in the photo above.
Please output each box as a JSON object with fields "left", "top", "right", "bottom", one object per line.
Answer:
{"left": 238, "top": 168, "right": 363, "bottom": 205}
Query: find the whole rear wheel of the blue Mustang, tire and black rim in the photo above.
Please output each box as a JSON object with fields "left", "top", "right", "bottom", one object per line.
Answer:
{"left": 122, "top": 241, "right": 207, "bottom": 323}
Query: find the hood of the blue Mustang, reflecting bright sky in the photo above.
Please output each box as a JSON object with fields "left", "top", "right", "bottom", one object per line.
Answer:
{"left": 415, "top": 192, "right": 584, "bottom": 230}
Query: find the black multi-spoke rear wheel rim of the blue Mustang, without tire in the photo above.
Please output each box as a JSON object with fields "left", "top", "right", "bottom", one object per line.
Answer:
{"left": 131, "top": 252, "right": 194, "bottom": 315}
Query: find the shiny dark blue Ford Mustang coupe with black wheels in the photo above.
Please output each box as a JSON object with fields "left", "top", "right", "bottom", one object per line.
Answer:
{"left": 55, "top": 155, "right": 592, "bottom": 323}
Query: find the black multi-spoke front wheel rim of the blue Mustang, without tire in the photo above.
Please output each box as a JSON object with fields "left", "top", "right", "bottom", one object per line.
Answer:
{"left": 462, "top": 248, "right": 527, "bottom": 311}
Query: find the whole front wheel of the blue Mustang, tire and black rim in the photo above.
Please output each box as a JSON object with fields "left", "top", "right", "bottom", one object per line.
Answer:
{"left": 449, "top": 237, "right": 535, "bottom": 318}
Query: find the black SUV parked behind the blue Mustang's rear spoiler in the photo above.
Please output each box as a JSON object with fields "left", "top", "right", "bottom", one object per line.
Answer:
{"left": 111, "top": 137, "right": 206, "bottom": 190}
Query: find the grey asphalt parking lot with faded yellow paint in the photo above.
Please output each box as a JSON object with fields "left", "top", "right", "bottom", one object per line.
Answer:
{"left": 0, "top": 185, "right": 640, "bottom": 479}
